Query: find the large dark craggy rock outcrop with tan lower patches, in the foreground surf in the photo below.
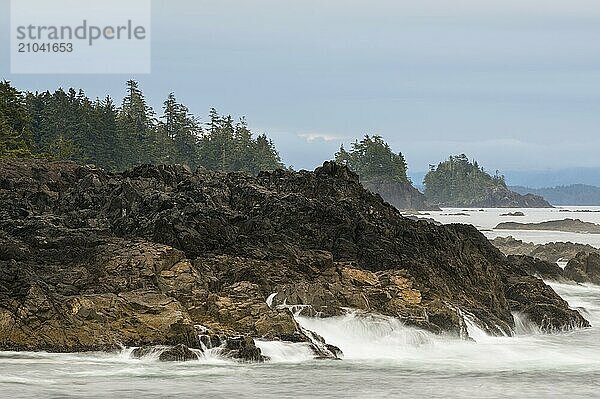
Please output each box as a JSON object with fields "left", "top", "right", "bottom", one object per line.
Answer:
{"left": 0, "top": 160, "right": 588, "bottom": 361}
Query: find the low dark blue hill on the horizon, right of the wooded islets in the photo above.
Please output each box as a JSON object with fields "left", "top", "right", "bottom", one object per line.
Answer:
{"left": 510, "top": 184, "right": 600, "bottom": 206}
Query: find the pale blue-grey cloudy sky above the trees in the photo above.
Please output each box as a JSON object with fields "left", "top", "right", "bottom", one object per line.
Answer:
{"left": 0, "top": 0, "right": 600, "bottom": 183}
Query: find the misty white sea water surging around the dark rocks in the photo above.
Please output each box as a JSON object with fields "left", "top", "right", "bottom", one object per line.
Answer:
{"left": 0, "top": 210, "right": 600, "bottom": 398}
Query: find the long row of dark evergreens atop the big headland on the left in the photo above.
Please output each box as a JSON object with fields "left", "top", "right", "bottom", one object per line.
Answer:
{"left": 0, "top": 80, "right": 283, "bottom": 174}
